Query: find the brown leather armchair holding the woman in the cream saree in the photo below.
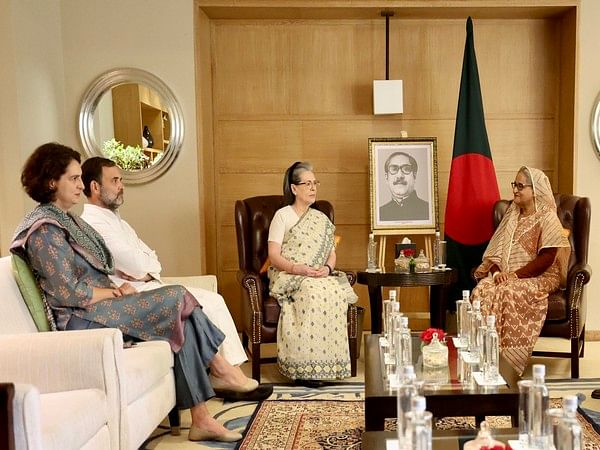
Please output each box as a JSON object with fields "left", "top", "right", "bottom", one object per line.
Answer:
{"left": 235, "top": 195, "right": 360, "bottom": 381}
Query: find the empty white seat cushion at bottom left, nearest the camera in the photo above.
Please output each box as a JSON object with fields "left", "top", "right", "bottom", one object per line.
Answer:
{"left": 40, "top": 389, "right": 110, "bottom": 449}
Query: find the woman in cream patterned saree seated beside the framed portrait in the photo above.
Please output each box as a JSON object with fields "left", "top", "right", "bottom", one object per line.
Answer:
{"left": 269, "top": 162, "right": 357, "bottom": 385}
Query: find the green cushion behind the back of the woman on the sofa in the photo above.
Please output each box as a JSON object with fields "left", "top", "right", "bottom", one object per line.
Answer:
{"left": 11, "top": 254, "right": 56, "bottom": 331}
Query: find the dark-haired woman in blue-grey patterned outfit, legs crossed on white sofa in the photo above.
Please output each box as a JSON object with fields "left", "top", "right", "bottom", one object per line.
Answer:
{"left": 11, "top": 143, "right": 268, "bottom": 442}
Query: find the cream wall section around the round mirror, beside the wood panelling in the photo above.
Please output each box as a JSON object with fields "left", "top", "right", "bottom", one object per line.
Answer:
{"left": 61, "top": 0, "right": 202, "bottom": 275}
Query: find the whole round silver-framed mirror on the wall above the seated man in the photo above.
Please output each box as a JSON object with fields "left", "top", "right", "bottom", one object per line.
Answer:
{"left": 79, "top": 69, "right": 183, "bottom": 184}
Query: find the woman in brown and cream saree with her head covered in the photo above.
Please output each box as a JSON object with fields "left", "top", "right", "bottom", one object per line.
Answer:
{"left": 471, "top": 166, "right": 571, "bottom": 374}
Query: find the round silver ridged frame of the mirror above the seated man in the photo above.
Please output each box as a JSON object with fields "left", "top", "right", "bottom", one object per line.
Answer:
{"left": 79, "top": 68, "right": 184, "bottom": 184}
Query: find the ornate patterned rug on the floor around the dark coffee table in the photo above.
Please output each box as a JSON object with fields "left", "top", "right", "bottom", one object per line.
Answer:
{"left": 143, "top": 382, "right": 600, "bottom": 450}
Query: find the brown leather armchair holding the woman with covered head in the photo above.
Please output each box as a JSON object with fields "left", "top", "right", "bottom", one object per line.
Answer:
{"left": 494, "top": 194, "right": 592, "bottom": 378}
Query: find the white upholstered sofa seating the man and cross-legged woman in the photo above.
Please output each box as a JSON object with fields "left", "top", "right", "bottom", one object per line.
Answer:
{"left": 0, "top": 257, "right": 216, "bottom": 450}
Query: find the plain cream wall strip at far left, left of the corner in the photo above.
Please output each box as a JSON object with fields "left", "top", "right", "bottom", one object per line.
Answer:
{"left": 0, "top": 0, "right": 65, "bottom": 255}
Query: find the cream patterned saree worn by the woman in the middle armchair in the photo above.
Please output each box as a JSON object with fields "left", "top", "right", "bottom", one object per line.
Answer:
{"left": 269, "top": 208, "right": 357, "bottom": 380}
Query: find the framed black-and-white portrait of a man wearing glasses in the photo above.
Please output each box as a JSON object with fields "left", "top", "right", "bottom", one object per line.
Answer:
{"left": 369, "top": 137, "right": 438, "bottom": 235}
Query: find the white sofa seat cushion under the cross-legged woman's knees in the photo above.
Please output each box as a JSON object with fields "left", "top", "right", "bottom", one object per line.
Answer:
{"left": 123, "top": 341, "right": 174, "bottom": 405}
